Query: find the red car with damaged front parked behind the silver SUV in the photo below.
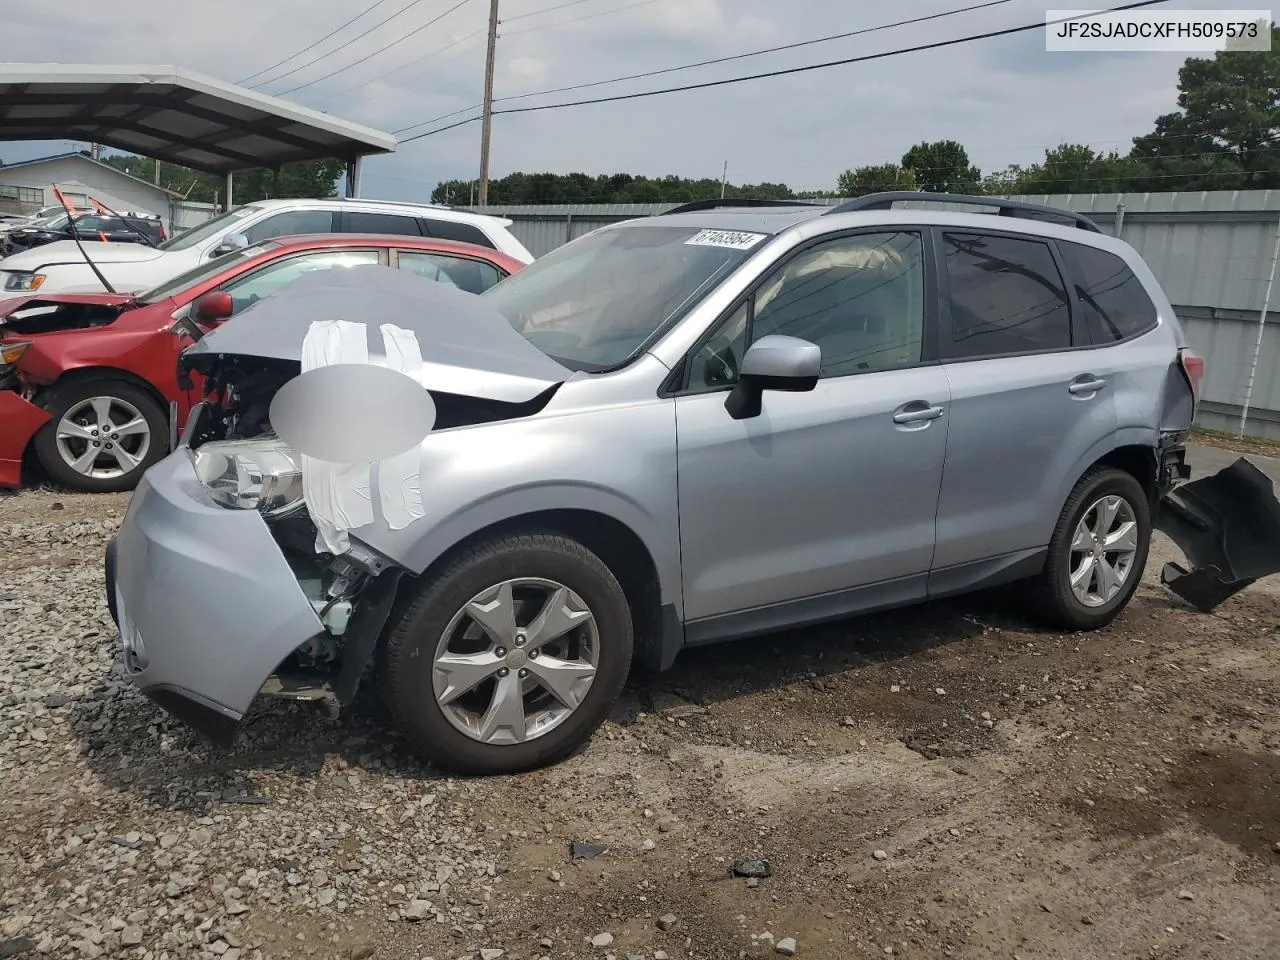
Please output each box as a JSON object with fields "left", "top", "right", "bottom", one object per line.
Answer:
{"left": 0, "top": 234, "right": 522, "bottom": 492}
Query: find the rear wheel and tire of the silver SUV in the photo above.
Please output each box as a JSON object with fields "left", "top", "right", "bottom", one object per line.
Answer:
{"left": 1036, "top": 467, "right": 1151, "bottom": 631}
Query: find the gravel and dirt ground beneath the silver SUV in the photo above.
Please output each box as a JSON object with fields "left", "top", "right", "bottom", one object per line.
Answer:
{"left": 0, "top": 455, "right": 1280, "bottom": 960}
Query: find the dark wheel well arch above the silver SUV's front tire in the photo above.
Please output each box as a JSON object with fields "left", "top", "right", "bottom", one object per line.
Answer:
{"left": 414, "top": 509, "right": 662, "bottom": 652}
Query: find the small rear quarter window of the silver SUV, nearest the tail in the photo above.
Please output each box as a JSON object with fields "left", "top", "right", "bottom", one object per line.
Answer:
{"left": 1057, "top": 242, "right": 1156, "bottom": 343}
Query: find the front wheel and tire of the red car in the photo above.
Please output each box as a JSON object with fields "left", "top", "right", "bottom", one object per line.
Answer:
{"left": 35, "top": 376, "right": 169, "bottom": 493}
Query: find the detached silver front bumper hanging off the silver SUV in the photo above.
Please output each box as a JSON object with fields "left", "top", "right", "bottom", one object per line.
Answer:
{"left": 106, "top": 448, "right": 324, "bottom": 745}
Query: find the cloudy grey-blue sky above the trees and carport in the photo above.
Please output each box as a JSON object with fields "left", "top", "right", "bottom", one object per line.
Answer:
{"left": 0, "top": 0, "right": 1259, "bottom": 202}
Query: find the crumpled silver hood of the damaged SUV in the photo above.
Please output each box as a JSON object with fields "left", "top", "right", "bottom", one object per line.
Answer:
{"left": 182, "top": 266, "right": 577, "bottom": 403}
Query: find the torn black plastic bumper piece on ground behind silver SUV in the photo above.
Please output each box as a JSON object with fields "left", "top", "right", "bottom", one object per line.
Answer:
{"left": 1155, "top": 457, "right": 1280, "bottom": 613}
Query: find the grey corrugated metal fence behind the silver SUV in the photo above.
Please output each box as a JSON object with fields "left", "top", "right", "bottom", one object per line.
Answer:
{"left": 471, "top": 191, "right": 1280, "bottom": 440}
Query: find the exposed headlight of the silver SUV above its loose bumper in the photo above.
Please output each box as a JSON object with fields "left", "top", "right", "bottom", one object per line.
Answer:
{"left": 191, "top": 439, "right": 302, "bottom": 517}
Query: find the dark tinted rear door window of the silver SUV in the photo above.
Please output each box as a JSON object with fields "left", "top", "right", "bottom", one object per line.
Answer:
{"left": 942, "top": 233, "right": 1071, "bottom": 357}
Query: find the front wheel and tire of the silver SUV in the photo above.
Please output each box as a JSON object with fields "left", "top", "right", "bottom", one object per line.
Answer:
{"left": 384, "top": 534, "right": 634, "bottom": 774}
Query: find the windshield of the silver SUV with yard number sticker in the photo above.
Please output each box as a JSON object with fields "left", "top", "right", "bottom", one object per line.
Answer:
{"left": 481, "top": 221, "right": 765, "bottom": 372}
